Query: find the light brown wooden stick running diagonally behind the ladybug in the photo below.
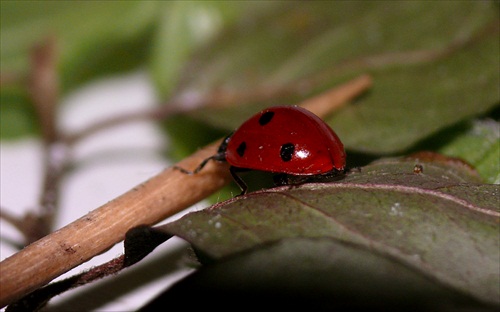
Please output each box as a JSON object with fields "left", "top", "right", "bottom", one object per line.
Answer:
{"left": 0, "top": 76, "right": 371, "bottom": 308}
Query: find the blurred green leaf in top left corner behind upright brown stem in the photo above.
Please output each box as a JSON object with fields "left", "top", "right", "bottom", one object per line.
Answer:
{"left": 0, "top": 1, "right": 159, "bottom": 139}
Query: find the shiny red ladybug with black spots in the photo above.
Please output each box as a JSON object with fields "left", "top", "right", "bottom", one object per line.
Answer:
{"left": 176, "top": 106, "right": 346, "bottom": 195}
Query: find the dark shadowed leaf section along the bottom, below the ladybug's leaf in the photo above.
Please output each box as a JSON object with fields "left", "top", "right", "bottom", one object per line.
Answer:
{"left": 140, "top": 238, "right": 492, "bottom": 311}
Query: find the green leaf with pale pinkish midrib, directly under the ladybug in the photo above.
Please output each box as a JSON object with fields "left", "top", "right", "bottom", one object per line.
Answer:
{"left": 158, "top": 153, "right": 500, "bottom": 305}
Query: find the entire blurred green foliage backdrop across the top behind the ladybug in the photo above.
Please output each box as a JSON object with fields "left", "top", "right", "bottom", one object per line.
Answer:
{"left": 0, "top": 1, "right": 500, "bottom": 183}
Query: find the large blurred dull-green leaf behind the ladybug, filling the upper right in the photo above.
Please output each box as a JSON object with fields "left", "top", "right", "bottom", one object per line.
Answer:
{"left": 169, "top": 1, "right": 500, "bottom": 154}
